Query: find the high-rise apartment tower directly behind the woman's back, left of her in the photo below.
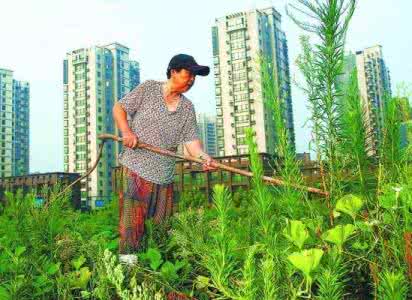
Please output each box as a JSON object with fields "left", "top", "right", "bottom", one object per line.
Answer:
{"left": 63, "top": 43, "right": 140, "bottom": 208}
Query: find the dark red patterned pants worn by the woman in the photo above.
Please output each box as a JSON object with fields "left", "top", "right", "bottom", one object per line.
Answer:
{"left": 119, "top": 167, "right": 173, "bottom": 254}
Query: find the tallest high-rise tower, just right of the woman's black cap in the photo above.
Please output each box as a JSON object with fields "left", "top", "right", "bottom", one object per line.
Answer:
{"left": 212, "top": 7, "right": 295, "bottom": 156}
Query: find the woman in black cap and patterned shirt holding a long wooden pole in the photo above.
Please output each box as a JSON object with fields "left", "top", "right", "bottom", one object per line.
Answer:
{"left": 113, "top": 54, "right": 215, "bottom": 264}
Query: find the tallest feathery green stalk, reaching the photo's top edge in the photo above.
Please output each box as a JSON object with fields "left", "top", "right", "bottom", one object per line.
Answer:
{"left": 288, "top": 0, "right": 356, "bottom": 204}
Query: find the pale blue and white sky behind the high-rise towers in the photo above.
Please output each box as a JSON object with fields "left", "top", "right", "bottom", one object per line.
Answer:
{"left": 0, "top": 0, "right": 412, "bottom": 172}
